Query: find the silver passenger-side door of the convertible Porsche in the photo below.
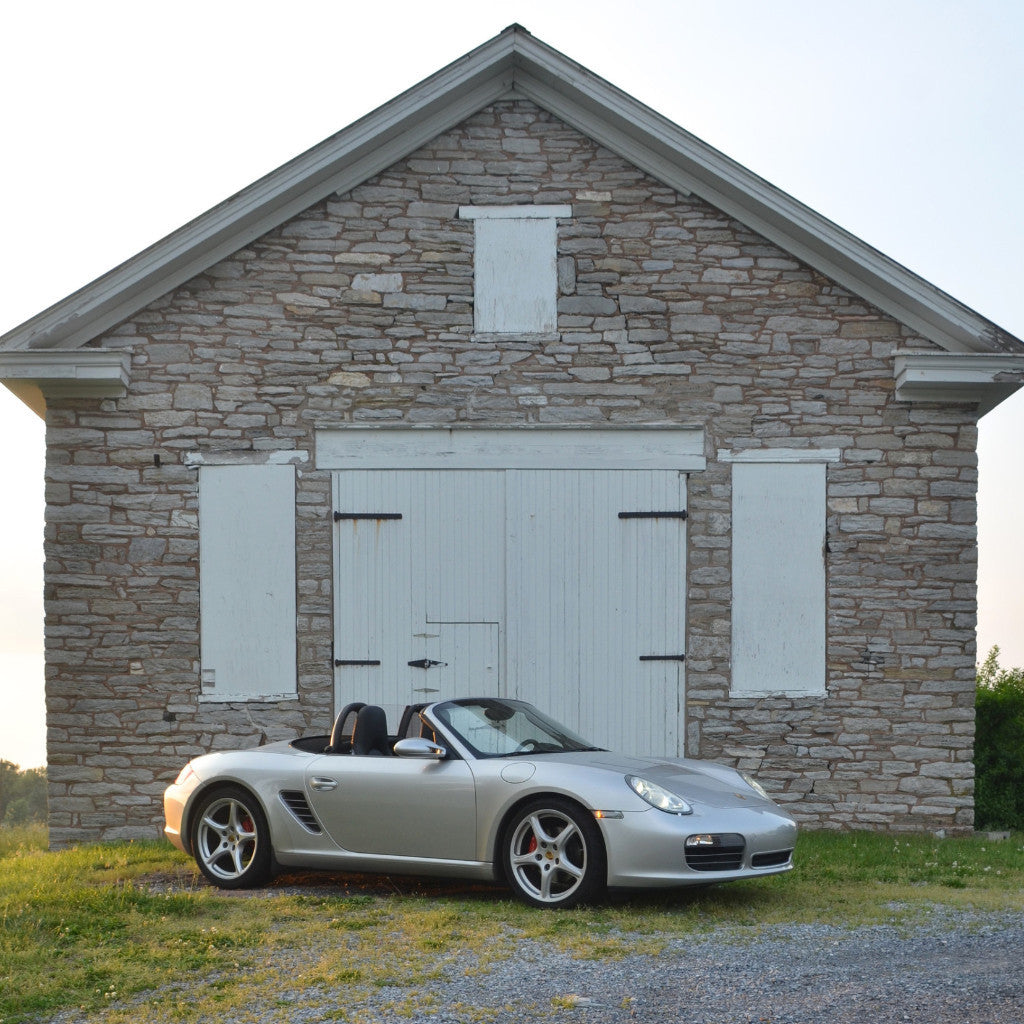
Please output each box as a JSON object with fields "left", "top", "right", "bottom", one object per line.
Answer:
{"left": 305, "top": 754, "right": 476, "bottom": 860}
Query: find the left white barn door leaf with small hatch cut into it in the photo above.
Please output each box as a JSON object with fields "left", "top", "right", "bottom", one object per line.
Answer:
{"left": 334, "top": 470, "right": 505, "bottom": 728}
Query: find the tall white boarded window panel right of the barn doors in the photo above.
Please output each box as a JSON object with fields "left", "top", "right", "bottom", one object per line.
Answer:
{"left": 731, "top": 456, "right": 825, "bottom": 697}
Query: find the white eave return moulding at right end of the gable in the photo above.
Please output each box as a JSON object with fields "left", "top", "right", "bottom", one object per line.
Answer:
{"left": 894, "top": 350, "right": 1024, "bottom": 416}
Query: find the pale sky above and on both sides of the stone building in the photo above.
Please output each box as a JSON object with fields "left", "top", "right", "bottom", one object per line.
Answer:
{"left": 0, "top": 0, "right": 1024, "bottom": 767}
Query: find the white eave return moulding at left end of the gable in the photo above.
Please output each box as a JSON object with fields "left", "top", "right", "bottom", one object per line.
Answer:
{"left": 0, "top": 348, "right": 131, "bottom": 417}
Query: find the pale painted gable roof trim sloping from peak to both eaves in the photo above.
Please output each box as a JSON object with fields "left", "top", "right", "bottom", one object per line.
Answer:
{"left": 0, "top": 25, "right": 1024, "bottom": 408}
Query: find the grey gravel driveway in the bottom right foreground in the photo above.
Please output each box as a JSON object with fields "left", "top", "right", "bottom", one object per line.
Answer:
{"left": 430, "top": 915, "right": 1024, "bottom": 1024}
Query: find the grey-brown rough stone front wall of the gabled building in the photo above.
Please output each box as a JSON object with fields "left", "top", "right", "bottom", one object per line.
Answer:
{"left": 46, "top": 102, "right": 976, "bottom": 845}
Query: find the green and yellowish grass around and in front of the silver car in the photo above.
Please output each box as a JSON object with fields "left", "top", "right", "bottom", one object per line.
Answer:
{"left": 0, "top": 827, "right": 1024, "bottom": 1024}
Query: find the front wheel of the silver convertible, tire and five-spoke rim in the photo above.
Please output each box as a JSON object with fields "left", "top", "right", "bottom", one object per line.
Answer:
{"left": 501, "top": 797, "right": 607, "bottom": 907}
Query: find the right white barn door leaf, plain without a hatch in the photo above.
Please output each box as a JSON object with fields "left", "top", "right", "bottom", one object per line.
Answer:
{"left": 506, "top": 470, "right": 686, "bottom": 756}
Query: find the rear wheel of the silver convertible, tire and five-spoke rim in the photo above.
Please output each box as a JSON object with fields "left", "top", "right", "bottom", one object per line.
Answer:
{"left": 191, "top": 785, "right": 273, "bottom": 889}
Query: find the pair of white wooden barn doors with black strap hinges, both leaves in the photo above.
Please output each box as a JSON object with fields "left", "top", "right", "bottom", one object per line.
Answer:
{"left": 334, "top": 452, "right": 686, "bottom": 756}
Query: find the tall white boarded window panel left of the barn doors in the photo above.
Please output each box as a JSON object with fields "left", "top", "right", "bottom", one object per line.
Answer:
{"left": 199, "top": 465, "right": 296, "bottom": 700}
